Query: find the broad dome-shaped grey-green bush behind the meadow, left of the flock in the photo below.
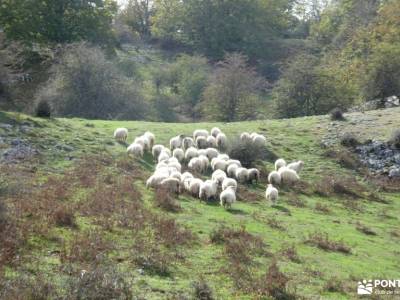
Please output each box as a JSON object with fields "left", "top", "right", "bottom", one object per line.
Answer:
{"left": 36, "top": 43, "right": 146, "bottom": 119}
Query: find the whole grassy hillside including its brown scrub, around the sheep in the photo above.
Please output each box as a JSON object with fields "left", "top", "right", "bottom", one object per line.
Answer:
{"left": 0, "top": 109, "right": 400, "bottom": 299}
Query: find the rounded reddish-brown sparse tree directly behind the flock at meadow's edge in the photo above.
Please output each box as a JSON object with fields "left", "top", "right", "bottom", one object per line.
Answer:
{"left": 201, "top": 53, "right": 263, "bottom": 122}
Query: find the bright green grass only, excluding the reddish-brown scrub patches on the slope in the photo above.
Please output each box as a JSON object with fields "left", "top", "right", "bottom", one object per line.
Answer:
{"left": 0, "top": 109, "right": 400, "bottom": 299}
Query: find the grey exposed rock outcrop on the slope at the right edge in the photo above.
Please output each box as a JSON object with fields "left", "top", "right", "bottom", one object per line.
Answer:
{"left": 356, "top": 140, "right": 400, "bottom": 178}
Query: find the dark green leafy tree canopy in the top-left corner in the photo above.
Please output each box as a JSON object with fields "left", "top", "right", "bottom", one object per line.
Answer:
{"left": 0, "top": 0, "right": 117, "bottom": 44}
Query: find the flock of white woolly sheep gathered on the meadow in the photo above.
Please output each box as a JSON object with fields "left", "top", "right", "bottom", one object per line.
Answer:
{"left": 114, "top": 127, "right": 304, "bottom": 208}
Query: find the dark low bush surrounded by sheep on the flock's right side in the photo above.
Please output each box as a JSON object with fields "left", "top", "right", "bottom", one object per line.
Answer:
{"left": 228, "top": 138, "right": 278, "bottom": 167}
